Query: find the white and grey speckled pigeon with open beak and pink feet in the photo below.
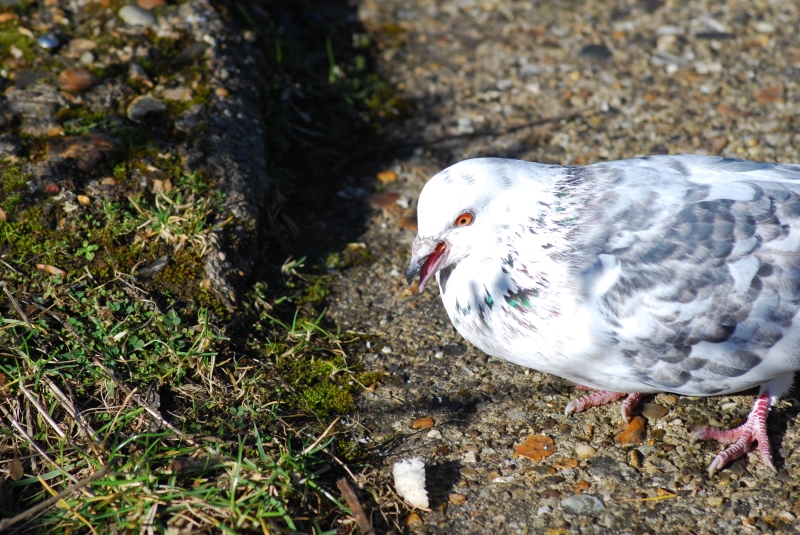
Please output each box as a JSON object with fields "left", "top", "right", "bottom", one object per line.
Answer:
{"left": 406, "top": 155, "right": 800, "bottom": 476}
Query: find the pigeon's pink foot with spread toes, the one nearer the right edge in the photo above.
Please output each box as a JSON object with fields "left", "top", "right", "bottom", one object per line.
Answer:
{"left": 692, "top": 392, "right": 777, "bottom": 477}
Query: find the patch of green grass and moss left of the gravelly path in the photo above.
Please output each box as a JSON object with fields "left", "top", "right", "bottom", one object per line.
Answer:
{"left": 0, "top": 0, "right": 404, "bottom": 534}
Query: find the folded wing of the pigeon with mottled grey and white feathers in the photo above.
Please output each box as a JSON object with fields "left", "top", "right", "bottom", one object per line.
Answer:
{"left": 573, "top": 156, "right": 800, "bottom": 394}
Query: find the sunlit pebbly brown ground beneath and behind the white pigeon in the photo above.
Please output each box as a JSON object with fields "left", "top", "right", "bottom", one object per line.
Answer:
{"left": 324, "top": 0, "right": 800, "bottom": 534}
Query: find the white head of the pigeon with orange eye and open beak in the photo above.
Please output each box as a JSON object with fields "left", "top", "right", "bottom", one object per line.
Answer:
{"left": 406, "top": 158, "right": 511, "bottom": 293}
